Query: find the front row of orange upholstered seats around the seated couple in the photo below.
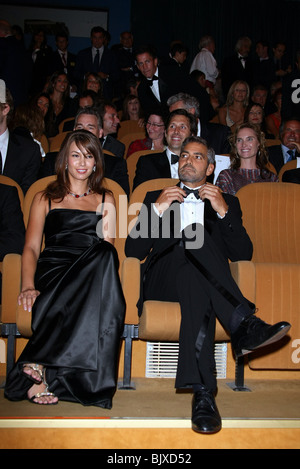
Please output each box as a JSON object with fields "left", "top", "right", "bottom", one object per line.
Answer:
{"left": 1, "top": 176, "right": 300, "bottom": 389}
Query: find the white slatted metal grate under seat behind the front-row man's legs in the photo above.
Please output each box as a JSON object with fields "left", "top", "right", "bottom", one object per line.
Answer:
{"left": 146, "top": 342, "right": 227, "bottom": 379}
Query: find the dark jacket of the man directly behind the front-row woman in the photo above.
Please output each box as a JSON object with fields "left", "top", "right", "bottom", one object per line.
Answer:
{"left": 39, "top": 152, "right": 129, "bottom": 195}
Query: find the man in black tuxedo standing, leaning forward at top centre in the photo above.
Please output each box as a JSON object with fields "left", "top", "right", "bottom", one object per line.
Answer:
{"left": 135, "top": 46, "right": 204, "bottom": 113}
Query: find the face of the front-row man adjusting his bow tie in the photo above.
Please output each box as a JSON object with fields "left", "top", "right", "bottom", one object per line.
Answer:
{"left": 178, "top": 142, "right": 214, "bottom": 188}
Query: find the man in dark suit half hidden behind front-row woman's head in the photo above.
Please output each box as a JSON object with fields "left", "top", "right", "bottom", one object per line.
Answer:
{"left": 40, "top": 108, "right": 129, "bottom": 195}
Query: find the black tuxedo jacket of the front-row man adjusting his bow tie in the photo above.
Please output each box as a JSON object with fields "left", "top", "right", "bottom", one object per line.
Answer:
{"left": 125, "top": 186, "right": 253, "bottom": 307}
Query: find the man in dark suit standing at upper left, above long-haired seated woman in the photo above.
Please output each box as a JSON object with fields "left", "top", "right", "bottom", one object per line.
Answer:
{"left": 51, "top": 31, "right": 76, "bottom": 88}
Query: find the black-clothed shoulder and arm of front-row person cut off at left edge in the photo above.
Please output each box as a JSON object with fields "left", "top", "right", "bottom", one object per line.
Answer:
{"left": 0, "top": 184, "right": 25, "bottom": 304}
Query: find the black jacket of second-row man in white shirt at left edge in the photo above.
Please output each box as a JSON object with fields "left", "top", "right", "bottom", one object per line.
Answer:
{"left": 3, "top": 132, "right": 42, "bottom": 194}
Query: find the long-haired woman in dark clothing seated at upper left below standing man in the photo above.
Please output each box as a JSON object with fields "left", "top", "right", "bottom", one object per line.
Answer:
{"left": 46, "top": 72, "right": 76, "bottom": 137}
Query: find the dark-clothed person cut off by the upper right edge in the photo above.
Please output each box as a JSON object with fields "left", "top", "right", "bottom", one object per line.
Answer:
{"left": 281, "top": 49, "right": 300, "bottom": 120}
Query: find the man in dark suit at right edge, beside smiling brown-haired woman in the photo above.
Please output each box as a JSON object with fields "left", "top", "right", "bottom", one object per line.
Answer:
{"left": 268, "top": 118, "right": 300, "bottom": 173}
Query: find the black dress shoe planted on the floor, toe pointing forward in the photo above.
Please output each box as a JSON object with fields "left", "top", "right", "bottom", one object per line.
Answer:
{"left": 192, "top": 388, "right": 222, "bottom": 433}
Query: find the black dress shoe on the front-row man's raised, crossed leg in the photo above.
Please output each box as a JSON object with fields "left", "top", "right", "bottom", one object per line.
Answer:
{"left": 231, "top": 315, "right": 291, "bottom": 357}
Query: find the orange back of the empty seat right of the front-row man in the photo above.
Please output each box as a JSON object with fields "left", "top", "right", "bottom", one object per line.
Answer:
{"left": 236, "top": 182, "right": 300, "bottom": 264}
